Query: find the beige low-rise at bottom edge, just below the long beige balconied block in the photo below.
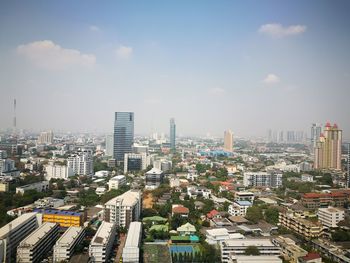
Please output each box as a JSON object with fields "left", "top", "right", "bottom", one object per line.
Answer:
{"left": 272, "top": 236, "right": 308, "bottom": 263}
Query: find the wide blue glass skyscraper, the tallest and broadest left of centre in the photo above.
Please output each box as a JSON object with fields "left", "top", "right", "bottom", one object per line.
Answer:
{"left": 113, "top": 112, "right": 134, "bottom": 162}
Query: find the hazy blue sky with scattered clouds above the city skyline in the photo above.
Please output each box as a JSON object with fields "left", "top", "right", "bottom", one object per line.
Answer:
{"left": 0, "top": 0, "right": 350, "bottom": 139}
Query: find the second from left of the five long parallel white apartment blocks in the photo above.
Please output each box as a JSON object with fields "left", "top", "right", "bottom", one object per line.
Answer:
{"left": 17, "top": 222, "right": 60, "bottom": 263}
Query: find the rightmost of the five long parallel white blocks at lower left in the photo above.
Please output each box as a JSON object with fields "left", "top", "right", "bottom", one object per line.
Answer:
{"left": 122, "top": 222, "right": 142, "bottom": 263}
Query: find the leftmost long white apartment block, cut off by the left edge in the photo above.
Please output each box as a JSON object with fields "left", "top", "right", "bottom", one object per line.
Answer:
{"left": 0, "top": 213, "right": 39, "bottom": 263}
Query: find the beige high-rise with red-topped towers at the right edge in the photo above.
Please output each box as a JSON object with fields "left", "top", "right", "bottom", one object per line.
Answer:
{"left": 314, "top": 123, "right": 342, "bottom": 170}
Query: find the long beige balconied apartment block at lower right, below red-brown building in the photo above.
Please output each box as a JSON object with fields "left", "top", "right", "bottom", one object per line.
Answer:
{"left": 278, "top": 212, "right": 322, "bottom": 239}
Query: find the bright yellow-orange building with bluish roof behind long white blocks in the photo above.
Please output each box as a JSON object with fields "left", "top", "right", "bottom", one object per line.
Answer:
{"left": 38, "top": 210, "right": 84, "bottom": 227}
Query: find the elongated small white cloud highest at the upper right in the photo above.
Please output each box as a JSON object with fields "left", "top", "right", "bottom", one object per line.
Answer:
{"left": 259, "top": 24, "right": 306, "bottom": 37}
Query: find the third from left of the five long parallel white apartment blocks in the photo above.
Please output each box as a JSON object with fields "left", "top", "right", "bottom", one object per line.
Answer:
{"left": 53, "top": 226, "right": 85, "bottom": 262}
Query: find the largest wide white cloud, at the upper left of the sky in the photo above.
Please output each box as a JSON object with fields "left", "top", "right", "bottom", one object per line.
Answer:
{"left": 17, "top": 40, "right": 96, "bottom": 70}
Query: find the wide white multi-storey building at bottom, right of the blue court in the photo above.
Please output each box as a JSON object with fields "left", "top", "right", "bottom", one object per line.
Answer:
{"left": 220, "top": 238, "right": 281, "bottom": 263}
